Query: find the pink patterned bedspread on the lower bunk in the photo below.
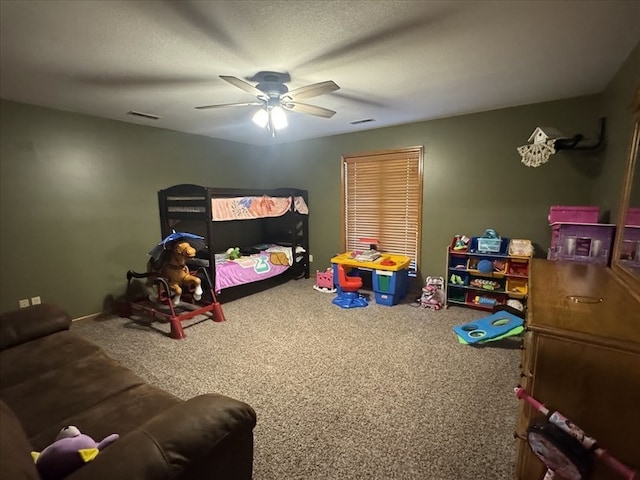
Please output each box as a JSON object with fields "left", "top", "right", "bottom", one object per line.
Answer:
{"left": 216, "top": 252, "right": 289, "bottom": 293}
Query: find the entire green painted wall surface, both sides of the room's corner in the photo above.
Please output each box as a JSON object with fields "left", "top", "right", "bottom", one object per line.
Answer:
{"left": 0, "top": 42, "right": 640, "bottom": 317}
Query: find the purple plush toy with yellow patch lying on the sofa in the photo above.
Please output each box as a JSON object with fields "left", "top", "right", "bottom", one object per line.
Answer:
{"left": 31, "top": 425, "right": 119, "bottom": 480}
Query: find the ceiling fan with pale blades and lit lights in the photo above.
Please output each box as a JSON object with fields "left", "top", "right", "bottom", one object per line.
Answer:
{"left": 195, "top": 72, "right": 340, "bottom": 137}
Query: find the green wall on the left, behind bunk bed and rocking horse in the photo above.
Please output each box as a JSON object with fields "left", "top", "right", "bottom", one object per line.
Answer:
{"left": 0, "top": 101, "right": 260, "bottom": 317}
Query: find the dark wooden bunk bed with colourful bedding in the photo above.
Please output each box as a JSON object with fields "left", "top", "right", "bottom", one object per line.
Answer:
{"left": 158, "top": 184, "right": 309, "bottom": 297}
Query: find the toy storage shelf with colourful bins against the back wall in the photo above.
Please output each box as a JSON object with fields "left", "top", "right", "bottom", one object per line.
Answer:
{"left": 446, "top": 239, "right": 531, "bottom": 311}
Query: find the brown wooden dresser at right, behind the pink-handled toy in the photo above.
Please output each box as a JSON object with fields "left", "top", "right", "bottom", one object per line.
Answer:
{"left": 516, "top": 259, "right": 640, "bottom": 480}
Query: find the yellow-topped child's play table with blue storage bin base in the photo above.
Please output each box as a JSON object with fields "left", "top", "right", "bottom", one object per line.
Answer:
{"left": 331, "top": 252, "right": 411, "bottom": 306}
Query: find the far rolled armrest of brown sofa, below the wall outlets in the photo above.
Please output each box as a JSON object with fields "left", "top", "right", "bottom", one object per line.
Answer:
{"left": 0, "top": 303, "right": 71, "bottom": 350}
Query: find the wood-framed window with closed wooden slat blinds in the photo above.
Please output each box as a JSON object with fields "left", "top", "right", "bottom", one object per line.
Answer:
{"left": 342, "top": 147, "right": 423, "bottom": 272}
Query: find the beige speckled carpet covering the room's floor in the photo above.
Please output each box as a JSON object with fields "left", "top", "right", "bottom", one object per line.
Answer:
{"left": 72, "top": 279, "right": 520, "bottom": 480}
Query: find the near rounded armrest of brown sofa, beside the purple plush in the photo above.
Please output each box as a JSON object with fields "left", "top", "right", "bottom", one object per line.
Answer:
{"left": 67, "top": 394, "right": 256, "bottom": 480}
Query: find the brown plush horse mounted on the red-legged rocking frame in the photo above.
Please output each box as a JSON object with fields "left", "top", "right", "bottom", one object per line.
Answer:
{"left": 149, "top": 241, "right": 202, "bottom": 305}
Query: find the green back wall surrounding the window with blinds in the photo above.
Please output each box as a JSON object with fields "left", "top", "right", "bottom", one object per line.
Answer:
{"left": 258, "top": 97, "right": 602, "bottom": 276}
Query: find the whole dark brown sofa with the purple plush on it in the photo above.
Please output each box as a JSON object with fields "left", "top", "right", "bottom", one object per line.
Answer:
{"left": 0, "top": 304, "right": 256, "bottom": 480}
